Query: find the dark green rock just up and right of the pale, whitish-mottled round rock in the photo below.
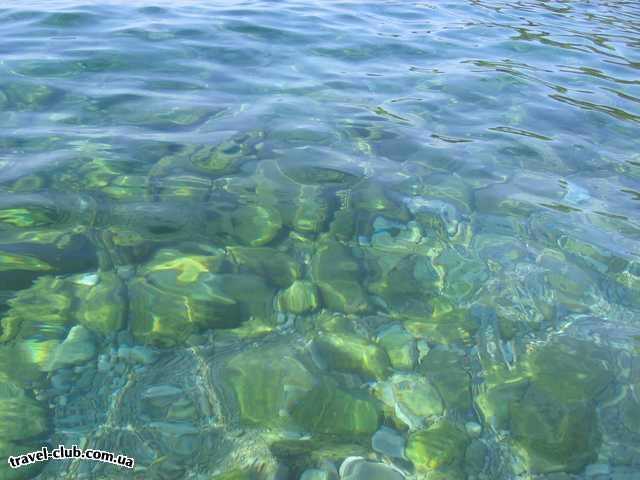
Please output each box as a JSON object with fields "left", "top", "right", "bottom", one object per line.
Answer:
{"left": 418, "top": 348, "right": 471, "bottom": 412}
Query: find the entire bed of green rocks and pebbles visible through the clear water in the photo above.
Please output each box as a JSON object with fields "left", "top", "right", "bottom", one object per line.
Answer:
{"left": 0, "top": 132, "right": 640, "bottom": 480}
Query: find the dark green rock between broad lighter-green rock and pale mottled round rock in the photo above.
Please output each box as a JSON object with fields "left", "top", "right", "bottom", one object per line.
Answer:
{"left": 291, "top": 378, "right": 380, "bottom": 437}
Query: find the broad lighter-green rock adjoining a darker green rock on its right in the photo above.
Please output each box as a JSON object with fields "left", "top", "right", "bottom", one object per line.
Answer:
{"left": 223, "top": 347, "right": 317, "bottom": 427}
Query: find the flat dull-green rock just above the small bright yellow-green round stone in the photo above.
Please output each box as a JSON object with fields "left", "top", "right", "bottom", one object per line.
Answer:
{"left": 227, "top": 247, "right": 301, "bottom": 288}
